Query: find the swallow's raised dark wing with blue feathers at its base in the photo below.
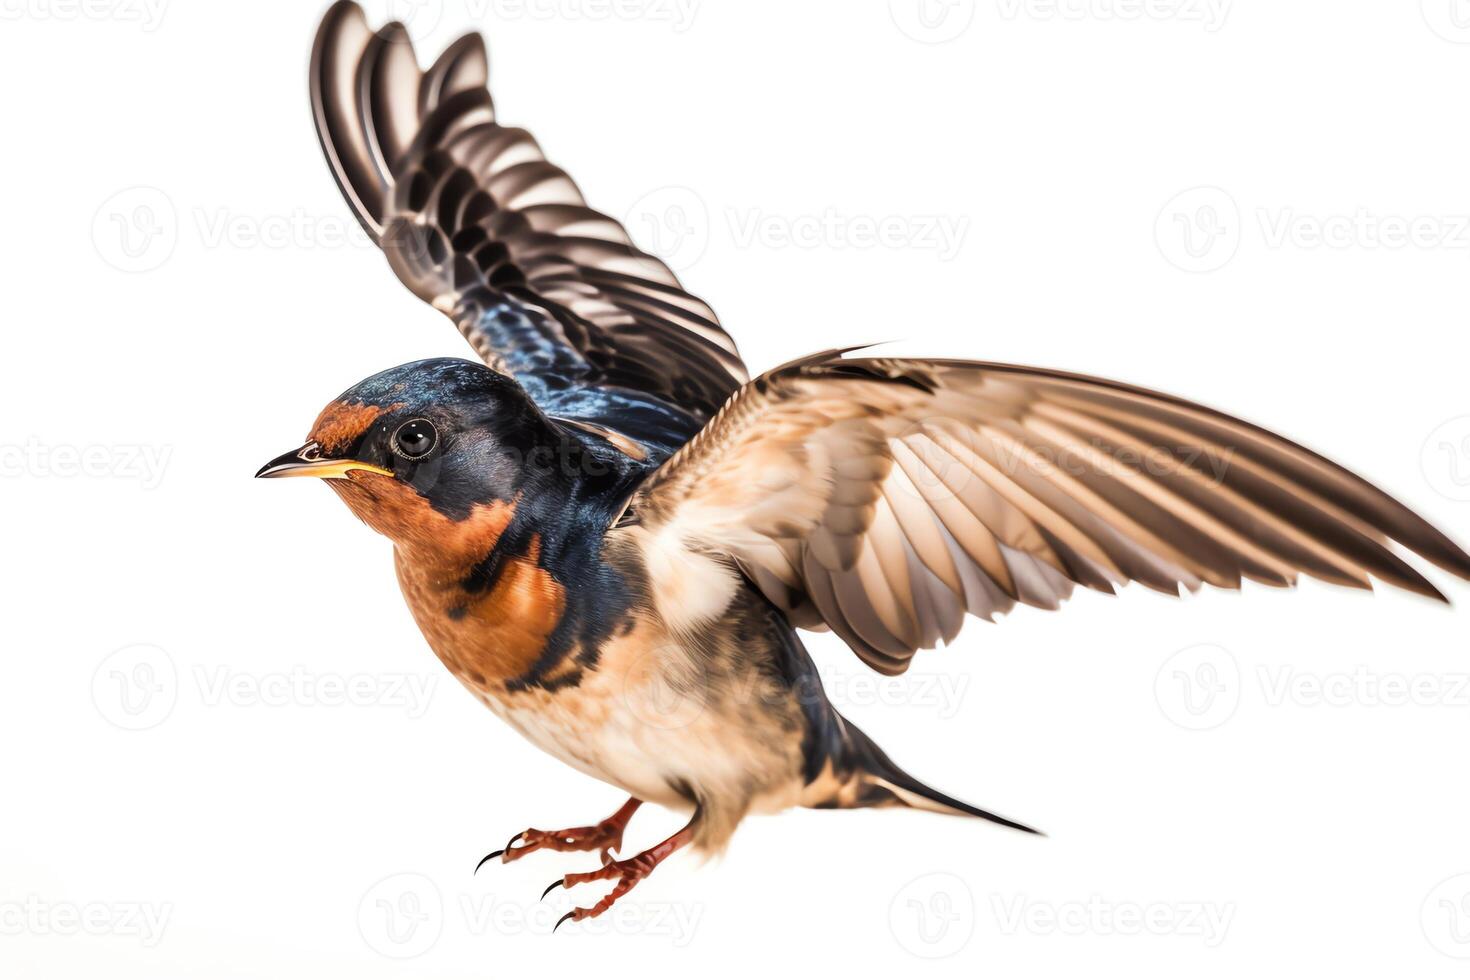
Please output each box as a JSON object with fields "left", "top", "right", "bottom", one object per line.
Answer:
{"left": 312, "top": 1, "right": 747, "bottom": 455}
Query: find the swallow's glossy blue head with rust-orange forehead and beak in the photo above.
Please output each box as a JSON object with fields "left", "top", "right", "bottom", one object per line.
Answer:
{"left": 256, "top": 359, "right": 557, "bottom": 547}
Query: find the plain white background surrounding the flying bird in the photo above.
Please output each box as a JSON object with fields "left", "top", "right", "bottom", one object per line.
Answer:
{"left": 0, "top": 0, "right": 1470, "bottom": 980}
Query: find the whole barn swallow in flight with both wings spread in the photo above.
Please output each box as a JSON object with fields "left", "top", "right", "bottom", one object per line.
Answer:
{"left": 259, "top": 3, "right": 1470, "bottom": 926}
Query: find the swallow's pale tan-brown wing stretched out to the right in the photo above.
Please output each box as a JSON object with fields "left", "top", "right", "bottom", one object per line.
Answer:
{"left": 629, "top": 354, "right": 1470, "bottom": 673}
